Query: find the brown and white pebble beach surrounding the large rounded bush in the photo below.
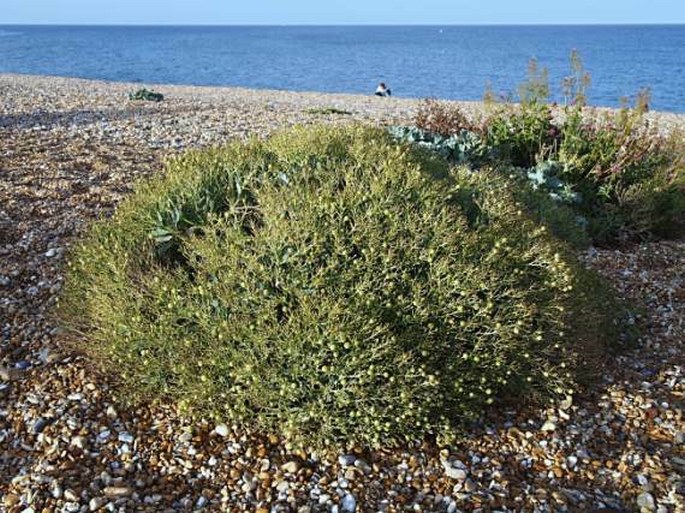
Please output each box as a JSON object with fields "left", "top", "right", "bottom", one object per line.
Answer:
{"left": 0, "top": 74, "right": 685, "bottom": 513}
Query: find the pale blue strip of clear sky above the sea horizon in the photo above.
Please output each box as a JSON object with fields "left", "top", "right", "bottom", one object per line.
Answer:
{"left": 0, "top": 0, "right": 685, "bottom": 25}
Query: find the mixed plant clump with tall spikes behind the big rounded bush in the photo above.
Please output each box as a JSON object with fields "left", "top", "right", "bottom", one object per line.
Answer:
{"left": 392, "top": 51, "right": 685, "bottom": 245}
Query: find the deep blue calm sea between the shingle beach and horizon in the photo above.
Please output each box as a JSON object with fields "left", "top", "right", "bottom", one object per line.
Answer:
{"left": 0, "top": 25, "right": 685, "bottom": 112}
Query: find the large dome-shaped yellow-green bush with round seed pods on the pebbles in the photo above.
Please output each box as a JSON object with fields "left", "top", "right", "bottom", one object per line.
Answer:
{"left": 60, "top": 127, "right": 620, "bottom": 444}
